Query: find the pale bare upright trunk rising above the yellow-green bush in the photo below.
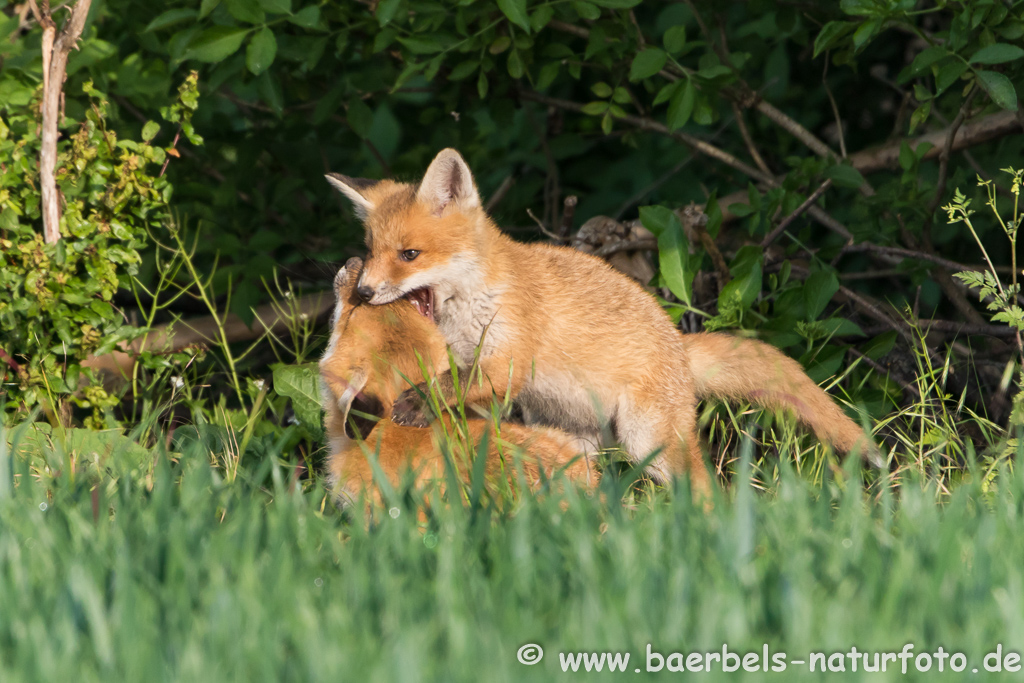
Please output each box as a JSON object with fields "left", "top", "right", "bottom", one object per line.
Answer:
{"left": 30, "top": 0, "right": 92, "bottom": 244}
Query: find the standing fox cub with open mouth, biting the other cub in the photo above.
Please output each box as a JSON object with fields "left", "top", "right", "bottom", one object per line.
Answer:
{"left": 328, "top": 150, "right": 871, "bottom": 490}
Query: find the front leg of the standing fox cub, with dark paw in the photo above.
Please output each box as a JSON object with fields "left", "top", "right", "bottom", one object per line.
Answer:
{"left": 391, "top": 356, "right": 523, "bottom": 427}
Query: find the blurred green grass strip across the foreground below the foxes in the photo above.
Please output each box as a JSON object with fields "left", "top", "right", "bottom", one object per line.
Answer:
{"left": 0, "top": 421, "right": 1024, "bottom": 682}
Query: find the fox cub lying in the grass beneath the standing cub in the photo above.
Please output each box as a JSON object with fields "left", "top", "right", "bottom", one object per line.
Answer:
{"left": 319, "top": 258, "right": 595, "bottom": 505}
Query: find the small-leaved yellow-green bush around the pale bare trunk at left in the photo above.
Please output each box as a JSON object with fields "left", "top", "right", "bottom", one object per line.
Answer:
{"left": 0, "top": 74, "right": 198, "bottom": 421}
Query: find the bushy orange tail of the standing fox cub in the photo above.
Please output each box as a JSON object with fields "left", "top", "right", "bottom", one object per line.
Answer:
{"left": 683, "top": 333, "right": 876, "bottom": 458}
